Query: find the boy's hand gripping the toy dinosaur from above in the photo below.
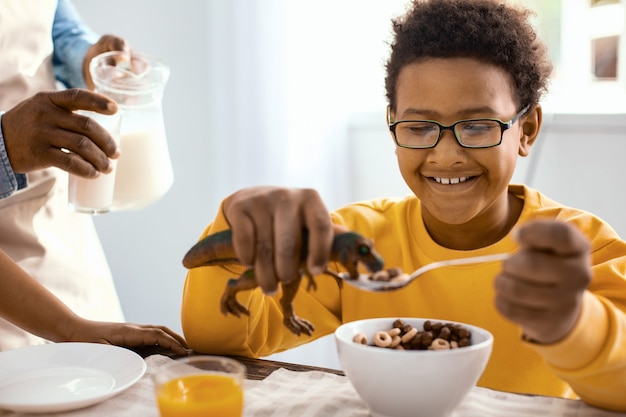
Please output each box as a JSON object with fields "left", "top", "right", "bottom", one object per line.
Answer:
{"left": 223, "top": 187, "right": 334, "bottom": 294}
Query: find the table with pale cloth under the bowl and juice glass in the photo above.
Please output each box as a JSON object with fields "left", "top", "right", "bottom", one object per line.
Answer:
{"left": 0, "top": 349, "right": 626, "bottom": 417}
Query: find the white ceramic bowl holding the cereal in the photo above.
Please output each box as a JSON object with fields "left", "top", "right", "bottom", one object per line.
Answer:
{"left": 335, "top": 317, "right": 493, "bottom": 417}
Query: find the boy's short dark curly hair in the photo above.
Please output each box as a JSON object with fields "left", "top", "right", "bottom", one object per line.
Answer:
{"left": 385, "top": 0, "right": 552, "bottom": 110}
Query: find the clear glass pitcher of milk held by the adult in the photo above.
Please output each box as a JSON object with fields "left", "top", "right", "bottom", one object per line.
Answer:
{"left": 89, "top": 51, "right": 174, "bottom": 211}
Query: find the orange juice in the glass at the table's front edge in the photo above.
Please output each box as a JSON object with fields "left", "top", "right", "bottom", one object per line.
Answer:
{"left": 157, "top": 374, "right": 243, "bottom": 417}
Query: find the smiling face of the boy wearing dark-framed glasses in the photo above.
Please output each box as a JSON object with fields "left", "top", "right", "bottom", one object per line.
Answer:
{"left": 392, "top": 58, "right": 535, "bottom": 226}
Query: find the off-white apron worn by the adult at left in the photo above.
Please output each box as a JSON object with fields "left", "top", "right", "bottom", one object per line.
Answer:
{"left": 0, "top": 0, "right": 123, "bottom": 351}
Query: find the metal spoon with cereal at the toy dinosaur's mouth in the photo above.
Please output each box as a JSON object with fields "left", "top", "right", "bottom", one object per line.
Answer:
{"left": 337, "top": 253, "right": 510, "bottom": 292}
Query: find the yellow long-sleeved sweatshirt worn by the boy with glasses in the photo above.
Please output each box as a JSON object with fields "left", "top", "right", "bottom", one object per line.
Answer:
{"left": 182, "top": 185, "right": 626, "bottom": 411}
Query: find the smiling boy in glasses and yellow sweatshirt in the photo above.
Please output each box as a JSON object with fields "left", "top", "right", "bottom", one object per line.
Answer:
{"left": 182, "top": 0, "right": 626, "bottom": 411}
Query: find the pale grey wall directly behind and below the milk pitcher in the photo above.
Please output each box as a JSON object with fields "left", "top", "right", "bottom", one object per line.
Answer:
{"left": 75, "top": 0, "right": 222, "bottom": 331}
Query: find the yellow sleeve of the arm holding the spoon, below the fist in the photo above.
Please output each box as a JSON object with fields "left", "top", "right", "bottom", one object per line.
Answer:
{"left": 528, "top": 247, "right": 626, "bottom": 412}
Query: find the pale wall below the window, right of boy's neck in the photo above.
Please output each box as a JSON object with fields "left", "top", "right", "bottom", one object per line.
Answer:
{"left": 525, "top": 113, "right": 626, "bottom": 238}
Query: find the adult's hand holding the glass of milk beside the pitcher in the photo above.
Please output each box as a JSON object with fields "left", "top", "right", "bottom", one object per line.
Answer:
{"left": 2, "top": 88, "right": 119, "bottom": 178}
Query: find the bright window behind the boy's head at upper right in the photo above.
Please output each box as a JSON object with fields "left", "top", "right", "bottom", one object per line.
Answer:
{"left": 517, "top": 0, "right": 626, "bottom": 113}
